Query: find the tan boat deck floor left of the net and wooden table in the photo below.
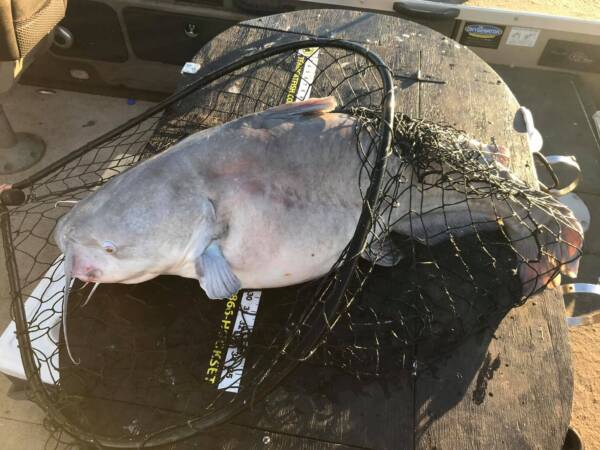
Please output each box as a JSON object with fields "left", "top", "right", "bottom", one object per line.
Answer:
{"left": 0, "top": 85, "right": 151, "bottom": 450}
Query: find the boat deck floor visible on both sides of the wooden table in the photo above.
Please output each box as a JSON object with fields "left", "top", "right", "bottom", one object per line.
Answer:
{"left": 0, "top": 62, "right": 600, "bottom": 450}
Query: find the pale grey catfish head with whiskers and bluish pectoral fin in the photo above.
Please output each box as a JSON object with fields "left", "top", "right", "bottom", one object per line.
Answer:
{"left": 54, "top": 169, "right": 241, "bottom": 361}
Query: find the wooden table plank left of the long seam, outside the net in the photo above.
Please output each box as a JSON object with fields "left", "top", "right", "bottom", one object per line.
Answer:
{"left": 176, "top": 10, "right": 423, "bottom": 449}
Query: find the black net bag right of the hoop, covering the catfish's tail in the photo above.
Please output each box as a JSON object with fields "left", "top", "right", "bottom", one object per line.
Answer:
{"left": 319, "top": 108, "right": 583, "bottom": 377}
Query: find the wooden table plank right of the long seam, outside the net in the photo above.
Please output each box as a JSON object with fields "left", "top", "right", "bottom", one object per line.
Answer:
{"left": 415, "top": 27, "right": 572, "bottom": 449}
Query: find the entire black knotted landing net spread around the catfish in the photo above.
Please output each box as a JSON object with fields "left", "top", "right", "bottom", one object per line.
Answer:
{"left": 2, "top": 39, "right": 581, "bottom": 447}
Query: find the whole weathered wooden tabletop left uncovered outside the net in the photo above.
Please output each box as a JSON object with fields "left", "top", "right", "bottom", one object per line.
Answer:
{"left": 170, "top": 10, "right": 572, "bottom": 450}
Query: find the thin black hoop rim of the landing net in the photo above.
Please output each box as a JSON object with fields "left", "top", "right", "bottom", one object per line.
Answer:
{"left": 0, "top": 38, "right": 395, "bottom": 448}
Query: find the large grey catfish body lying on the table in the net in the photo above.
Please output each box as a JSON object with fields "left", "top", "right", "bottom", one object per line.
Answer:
{"left": 55, "top": 97, "right": 581, "bottom": 298}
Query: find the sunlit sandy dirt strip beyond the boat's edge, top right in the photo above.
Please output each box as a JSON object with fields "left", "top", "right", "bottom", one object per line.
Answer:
{"left": 458, "top": 0, "right": 600, "bottom": 19}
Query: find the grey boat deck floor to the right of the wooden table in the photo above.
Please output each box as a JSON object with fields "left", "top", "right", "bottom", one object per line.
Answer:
{"left": 494, "top": 66, "right": 600, "bottom": 315}
